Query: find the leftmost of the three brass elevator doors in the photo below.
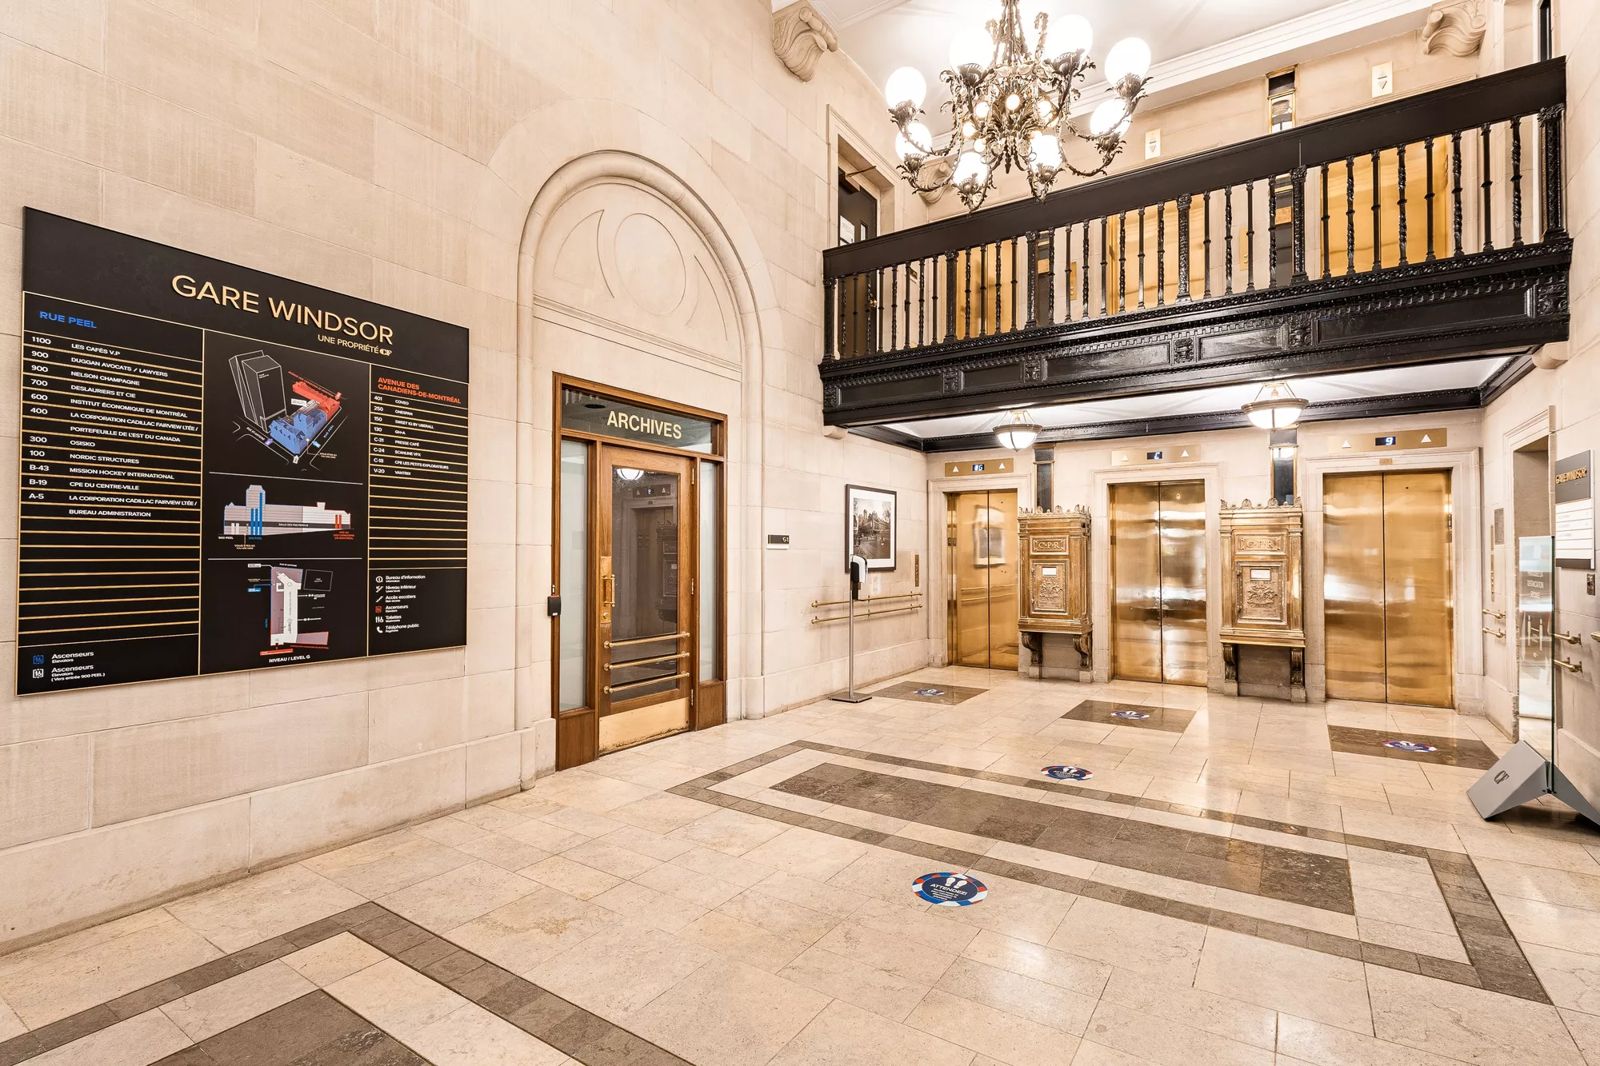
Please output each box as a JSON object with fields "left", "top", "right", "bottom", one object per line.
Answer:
{"left": 944, "top": 490, "right": 1018, "bottom": 671}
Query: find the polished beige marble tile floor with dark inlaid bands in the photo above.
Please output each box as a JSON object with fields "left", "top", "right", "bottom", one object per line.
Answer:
{"left": 0, "top": 669, "right": 1600, "bottom": 1066}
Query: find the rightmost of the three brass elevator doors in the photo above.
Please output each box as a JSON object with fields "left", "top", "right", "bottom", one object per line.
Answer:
{"left": 1322, "top": 471, "right": 1454, "bottom": 707}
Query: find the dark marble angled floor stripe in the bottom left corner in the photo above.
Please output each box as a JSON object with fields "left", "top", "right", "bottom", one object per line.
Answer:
{"left": 0, "top": 903, "right": 688, "bottom": 1066}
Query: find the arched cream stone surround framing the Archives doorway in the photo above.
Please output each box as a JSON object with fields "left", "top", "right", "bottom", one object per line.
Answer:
{"left": 508, "top": 145, "right": 771, "bottom": 778}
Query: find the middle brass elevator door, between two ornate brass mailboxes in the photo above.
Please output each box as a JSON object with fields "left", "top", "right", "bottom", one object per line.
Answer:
{"left": 1110, "top": 482, "right": 1206, "bottom": 685}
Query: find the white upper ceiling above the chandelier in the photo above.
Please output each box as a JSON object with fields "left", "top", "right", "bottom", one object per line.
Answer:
{"left": 800, "top": 0, "right": 1432, "bottom": 130}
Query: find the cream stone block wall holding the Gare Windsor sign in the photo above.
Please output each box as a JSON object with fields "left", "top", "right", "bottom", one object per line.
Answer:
{"left": 0, "top": 0, "right": 926, "bottom": 951}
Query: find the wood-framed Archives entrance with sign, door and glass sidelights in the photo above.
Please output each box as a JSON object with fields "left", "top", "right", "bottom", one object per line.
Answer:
{"left": 549, "top": 375, "right": 728, "bottom": 770}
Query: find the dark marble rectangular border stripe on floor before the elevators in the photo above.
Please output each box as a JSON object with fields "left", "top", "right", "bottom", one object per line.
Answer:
{"left": 669, "top": 741, "right": 1550, "bottom": 1004}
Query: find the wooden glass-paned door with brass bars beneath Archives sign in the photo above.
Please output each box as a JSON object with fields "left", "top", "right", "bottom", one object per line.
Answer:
{"left": 594, "top": 445, "right": 696, "bottom": 752}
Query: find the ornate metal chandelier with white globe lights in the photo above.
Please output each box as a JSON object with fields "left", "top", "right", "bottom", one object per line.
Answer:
{"left": 883, "top": 0, "right": 1150, "bottom": 211}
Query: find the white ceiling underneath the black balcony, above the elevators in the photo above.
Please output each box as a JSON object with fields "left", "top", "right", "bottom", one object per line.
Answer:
{"left": 890, "top": 355, "right": 1507, "bottom": 439}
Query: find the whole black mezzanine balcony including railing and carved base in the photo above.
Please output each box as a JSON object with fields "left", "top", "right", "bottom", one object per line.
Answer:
{"left": 819, "top": 59, "right": 1573, "bottom": 427}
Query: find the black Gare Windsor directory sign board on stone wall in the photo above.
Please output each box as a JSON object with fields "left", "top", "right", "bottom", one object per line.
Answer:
{"left": 18, "top": 210, "right": 467, "bottom": 693}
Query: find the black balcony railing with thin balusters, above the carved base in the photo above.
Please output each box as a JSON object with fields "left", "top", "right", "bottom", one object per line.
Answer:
{"left": 824, "top": 59, "right": 1566, "bottom": 362}
